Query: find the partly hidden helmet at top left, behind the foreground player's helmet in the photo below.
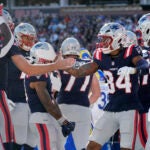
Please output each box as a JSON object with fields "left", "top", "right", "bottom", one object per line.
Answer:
{"left": 3, "top": 9, "right": 14, "bottom": 31}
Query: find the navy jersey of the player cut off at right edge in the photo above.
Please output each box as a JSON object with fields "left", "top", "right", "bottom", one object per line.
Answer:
{"left": 139, "top": 50, "right": 150, "bottom": 112}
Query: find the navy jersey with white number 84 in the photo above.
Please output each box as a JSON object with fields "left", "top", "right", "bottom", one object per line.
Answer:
{"left": 93, "top": 46, "right": 142, "bottom": 112}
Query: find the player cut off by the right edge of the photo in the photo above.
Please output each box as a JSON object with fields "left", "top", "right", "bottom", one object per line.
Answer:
{"left": 137, "top": 13, "right": 150, "bottom": 150}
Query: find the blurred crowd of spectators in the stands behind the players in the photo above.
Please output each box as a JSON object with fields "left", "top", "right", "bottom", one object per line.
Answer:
{"left": 13, "top": 12, "right": 140, "bottom": 52}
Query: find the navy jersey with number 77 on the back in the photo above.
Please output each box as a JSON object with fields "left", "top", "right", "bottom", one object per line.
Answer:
{"left": 57, "top": 67, "right": 93, "bottom": 107}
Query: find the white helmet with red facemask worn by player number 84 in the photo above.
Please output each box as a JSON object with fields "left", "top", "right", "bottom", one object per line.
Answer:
{"left": 98, "top": 22, "right": 126, "bottom": 54}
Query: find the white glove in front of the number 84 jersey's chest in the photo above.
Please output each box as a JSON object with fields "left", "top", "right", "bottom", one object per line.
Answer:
{"left": 117, "top": 66, "right": 136, "bottom": 75}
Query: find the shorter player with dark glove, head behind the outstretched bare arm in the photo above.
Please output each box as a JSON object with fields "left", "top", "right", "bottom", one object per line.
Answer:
{"left": 25, "top": 42, "right": 75, "bottom": 150}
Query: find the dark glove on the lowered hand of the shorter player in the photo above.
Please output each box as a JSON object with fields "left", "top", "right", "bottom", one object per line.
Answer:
{"left": 61, "top": 121, "right": 75, "bottom": 137}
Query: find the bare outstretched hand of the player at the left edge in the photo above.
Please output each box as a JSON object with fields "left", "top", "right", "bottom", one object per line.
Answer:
{"left": 56, "top": 54, "right": 75, "bottom": 70}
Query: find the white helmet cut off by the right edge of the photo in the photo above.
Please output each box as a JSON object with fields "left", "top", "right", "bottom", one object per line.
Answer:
{"left": 137, "top": 13, "right": 150, "bottom": 46}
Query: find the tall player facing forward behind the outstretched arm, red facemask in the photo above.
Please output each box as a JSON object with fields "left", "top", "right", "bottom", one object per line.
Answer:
{"left": 6, "top": 23, "right": 37, "bottom": 150}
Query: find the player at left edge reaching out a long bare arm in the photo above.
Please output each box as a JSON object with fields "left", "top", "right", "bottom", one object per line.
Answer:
{"left": 0, "top": 5, "right": 75, "bottom": 150}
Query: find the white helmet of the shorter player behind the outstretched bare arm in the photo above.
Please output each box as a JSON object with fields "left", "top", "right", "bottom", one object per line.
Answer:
{"left": 30, "top": 42, "right": 56, "bottom": 64}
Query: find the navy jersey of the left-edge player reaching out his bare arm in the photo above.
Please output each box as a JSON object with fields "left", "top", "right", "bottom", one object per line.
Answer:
{"left": 0, "top": 46, "right": 20, "bottom": 90}
